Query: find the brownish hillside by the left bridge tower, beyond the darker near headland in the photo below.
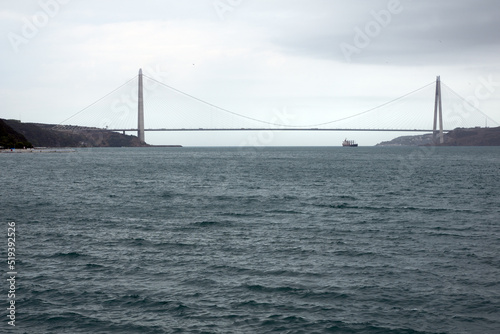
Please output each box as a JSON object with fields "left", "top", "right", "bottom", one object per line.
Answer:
{"left": 4, "top": 120, "right": 149, "bottom": 147}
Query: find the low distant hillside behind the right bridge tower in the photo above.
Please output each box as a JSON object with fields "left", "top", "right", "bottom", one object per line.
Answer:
{"left": 377, "top": 127, "right": 500, "bottom": 146}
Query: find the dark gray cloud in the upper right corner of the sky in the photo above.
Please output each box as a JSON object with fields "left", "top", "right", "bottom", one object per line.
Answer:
{"left": 254, "top": 0, "right": 500, "bottom": 65}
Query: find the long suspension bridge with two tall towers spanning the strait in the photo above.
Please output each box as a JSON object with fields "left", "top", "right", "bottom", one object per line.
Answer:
{"left": 59, "top": 69, "right": 496, "bottom": 143}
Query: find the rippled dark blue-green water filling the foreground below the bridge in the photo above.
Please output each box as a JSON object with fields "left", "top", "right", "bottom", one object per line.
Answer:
{"left": 0, "top": 147, "right": 500, "bottom": 333}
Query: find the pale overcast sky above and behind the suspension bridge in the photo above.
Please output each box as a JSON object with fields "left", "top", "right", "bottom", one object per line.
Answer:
{"left": 0, "top": 0, "right": 500, "bottom": 146}
